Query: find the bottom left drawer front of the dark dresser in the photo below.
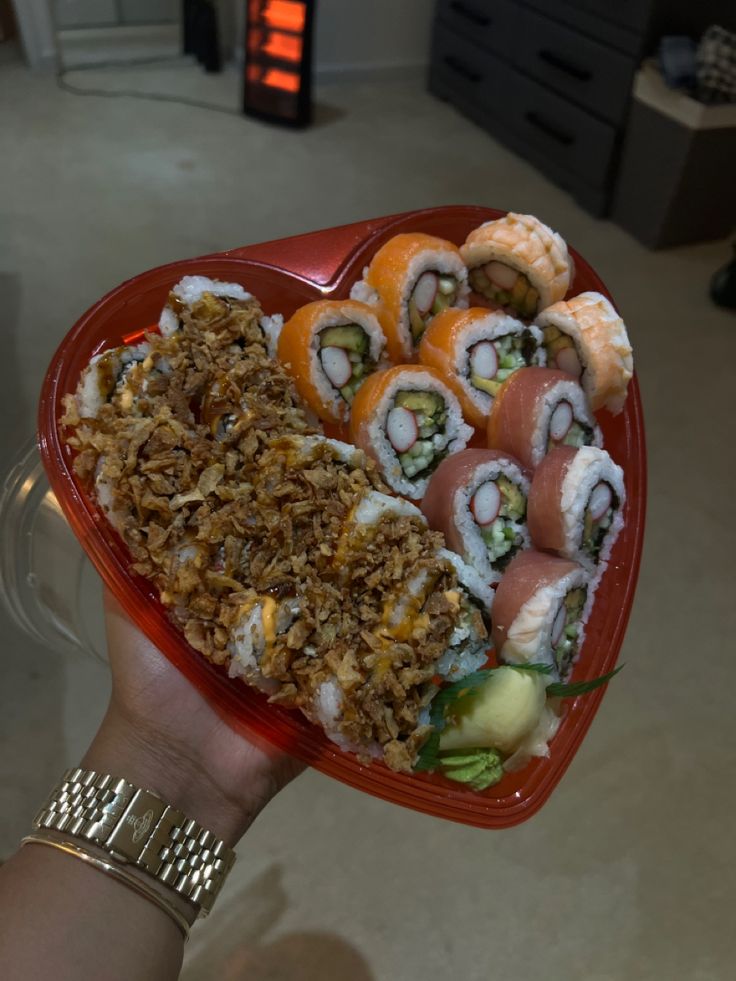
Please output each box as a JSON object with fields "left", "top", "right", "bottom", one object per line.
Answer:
{"left": 430, "top": 21, "right": 506, "bottom": 108}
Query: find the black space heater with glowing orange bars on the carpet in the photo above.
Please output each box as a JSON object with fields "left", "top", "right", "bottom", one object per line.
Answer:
{"left": 243, "top": 0, "right": 314, "bottom": 125}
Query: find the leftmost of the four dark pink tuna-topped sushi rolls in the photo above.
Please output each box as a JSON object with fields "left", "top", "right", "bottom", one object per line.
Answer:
{"left": 422, "top": 450, "right": 529, "bottom": 583}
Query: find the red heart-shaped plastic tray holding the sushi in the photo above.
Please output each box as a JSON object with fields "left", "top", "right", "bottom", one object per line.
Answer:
{"left": 39, "top": 207, "right": 646, "bottom": 828}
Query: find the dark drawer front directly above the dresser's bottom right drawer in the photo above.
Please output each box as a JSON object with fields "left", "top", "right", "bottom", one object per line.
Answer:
{"left": 514, "top": 10, "right": 636, "bottom": 125}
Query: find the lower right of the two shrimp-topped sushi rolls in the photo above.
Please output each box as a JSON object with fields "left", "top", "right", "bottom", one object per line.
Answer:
{"left": 537, "top": 293, "right": 634, "bottom": 415}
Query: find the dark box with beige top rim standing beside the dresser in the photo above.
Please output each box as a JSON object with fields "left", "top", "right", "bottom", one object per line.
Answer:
{"left": 611, "top": 63, "right": 736, "bottom": 248}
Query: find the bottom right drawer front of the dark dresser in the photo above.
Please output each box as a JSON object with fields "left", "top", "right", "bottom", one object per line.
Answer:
{"left": 503, "top": 69, "right": 616, "bottom": 187}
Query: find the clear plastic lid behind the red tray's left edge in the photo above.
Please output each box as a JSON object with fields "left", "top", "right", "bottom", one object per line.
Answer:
{"left": 0, "top": 440, "right": 106, "bottom": 660}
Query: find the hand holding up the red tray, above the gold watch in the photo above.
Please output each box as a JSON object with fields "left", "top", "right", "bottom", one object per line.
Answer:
{"left": 83, "top": 593, "right": 304, "bottom": 845}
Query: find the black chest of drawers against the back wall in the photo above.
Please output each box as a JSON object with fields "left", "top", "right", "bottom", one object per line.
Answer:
{"left": 429, "top": 0, "right": 734, "bottom": 215}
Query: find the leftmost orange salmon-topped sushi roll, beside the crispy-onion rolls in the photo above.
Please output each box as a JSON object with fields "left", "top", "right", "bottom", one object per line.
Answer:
{"left": 277, "top": 300, "right": 386, "bottom": 424}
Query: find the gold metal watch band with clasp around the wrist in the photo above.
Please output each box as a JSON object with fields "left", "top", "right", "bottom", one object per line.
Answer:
{"left": 29, "top": 768, "right": 235, "bottom": 916}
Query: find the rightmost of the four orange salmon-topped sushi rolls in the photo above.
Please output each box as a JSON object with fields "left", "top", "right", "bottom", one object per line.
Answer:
{"left": 419, "top": 307, "right": 545, "bottom": 429}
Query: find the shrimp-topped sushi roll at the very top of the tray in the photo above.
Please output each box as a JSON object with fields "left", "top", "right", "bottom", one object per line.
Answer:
{"left": 460, "top": 212, "right": 573, "bottom": 320}
